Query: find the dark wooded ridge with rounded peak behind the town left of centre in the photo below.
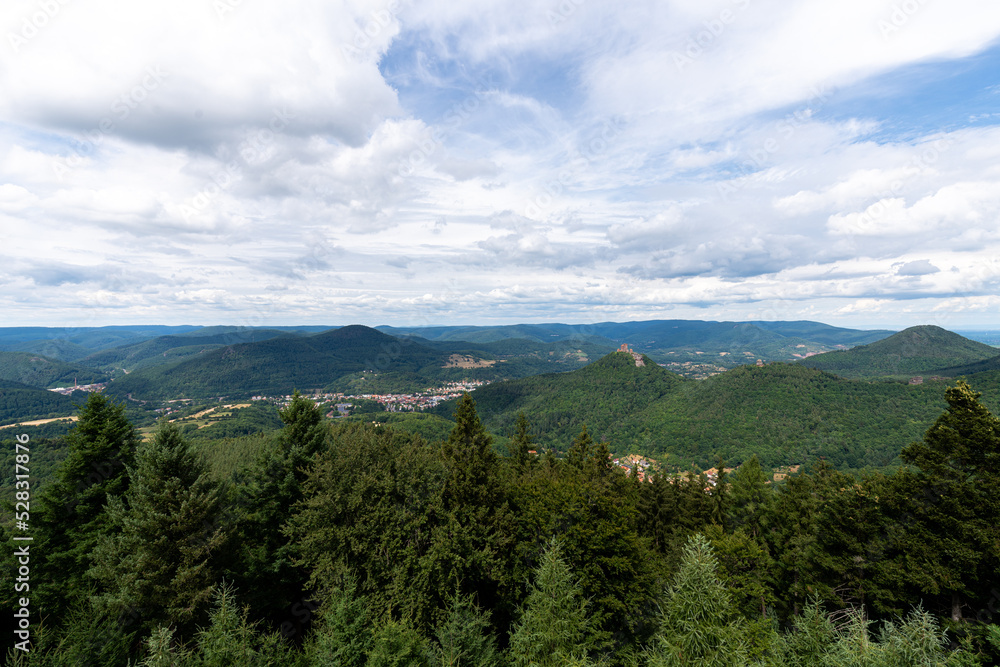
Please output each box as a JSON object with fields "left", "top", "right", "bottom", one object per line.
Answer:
{"left": 105, "top": 325, "right": 609, "bottom": 400}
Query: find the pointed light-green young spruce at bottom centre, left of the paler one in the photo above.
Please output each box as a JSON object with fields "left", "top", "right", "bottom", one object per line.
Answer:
{"left": 510, "top": 539, "right": 589, "bottom": 667}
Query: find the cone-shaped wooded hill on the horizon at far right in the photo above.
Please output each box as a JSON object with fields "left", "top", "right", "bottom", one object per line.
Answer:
{"left": 799, "top": 325, "right": 997, "bottom": 378}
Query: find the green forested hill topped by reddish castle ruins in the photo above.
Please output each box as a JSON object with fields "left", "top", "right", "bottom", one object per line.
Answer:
{"left": 460, "top": 353, "right": 998, "bottom": 468}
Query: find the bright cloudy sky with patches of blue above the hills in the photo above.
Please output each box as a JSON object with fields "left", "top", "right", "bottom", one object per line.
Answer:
{"left": 0, "top": 0, "right": 1000, "bottom": 329}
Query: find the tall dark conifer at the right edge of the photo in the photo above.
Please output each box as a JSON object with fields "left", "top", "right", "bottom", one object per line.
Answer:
{"left": 879, "top": 381, "right": 1000, "bottom": 622}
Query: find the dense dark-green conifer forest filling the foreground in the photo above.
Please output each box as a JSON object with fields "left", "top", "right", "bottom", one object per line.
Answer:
{"left": 3, "top": 383, "right": 1000, "bottom": 667}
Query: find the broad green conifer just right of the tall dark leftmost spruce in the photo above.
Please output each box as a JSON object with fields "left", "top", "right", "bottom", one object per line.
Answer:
{"left": 88, "top": 423, "right": 226, "bottom": 635}
